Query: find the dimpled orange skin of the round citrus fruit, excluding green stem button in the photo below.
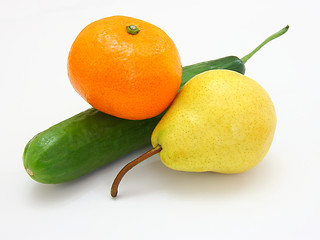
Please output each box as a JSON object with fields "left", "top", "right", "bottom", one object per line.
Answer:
{"left": 68, "top": 16, "right": 182, "bottom": 120}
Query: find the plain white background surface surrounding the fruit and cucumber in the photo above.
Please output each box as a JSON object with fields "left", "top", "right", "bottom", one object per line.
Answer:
{"left": 0, "top": 0, "right": 320, "bottom": 239}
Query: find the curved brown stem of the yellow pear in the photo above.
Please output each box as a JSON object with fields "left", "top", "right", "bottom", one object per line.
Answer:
{"left": 111, "top": 145, "right": 162, "bottom": 197}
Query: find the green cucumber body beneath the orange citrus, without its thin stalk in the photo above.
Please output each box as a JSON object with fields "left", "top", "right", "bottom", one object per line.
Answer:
{"left": 23, "top": 56, "right": 245, "bottom": 184}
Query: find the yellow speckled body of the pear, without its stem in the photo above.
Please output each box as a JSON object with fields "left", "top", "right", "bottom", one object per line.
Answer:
{"left": 152, "top": 70, "right": 276, "bottom": 173}
